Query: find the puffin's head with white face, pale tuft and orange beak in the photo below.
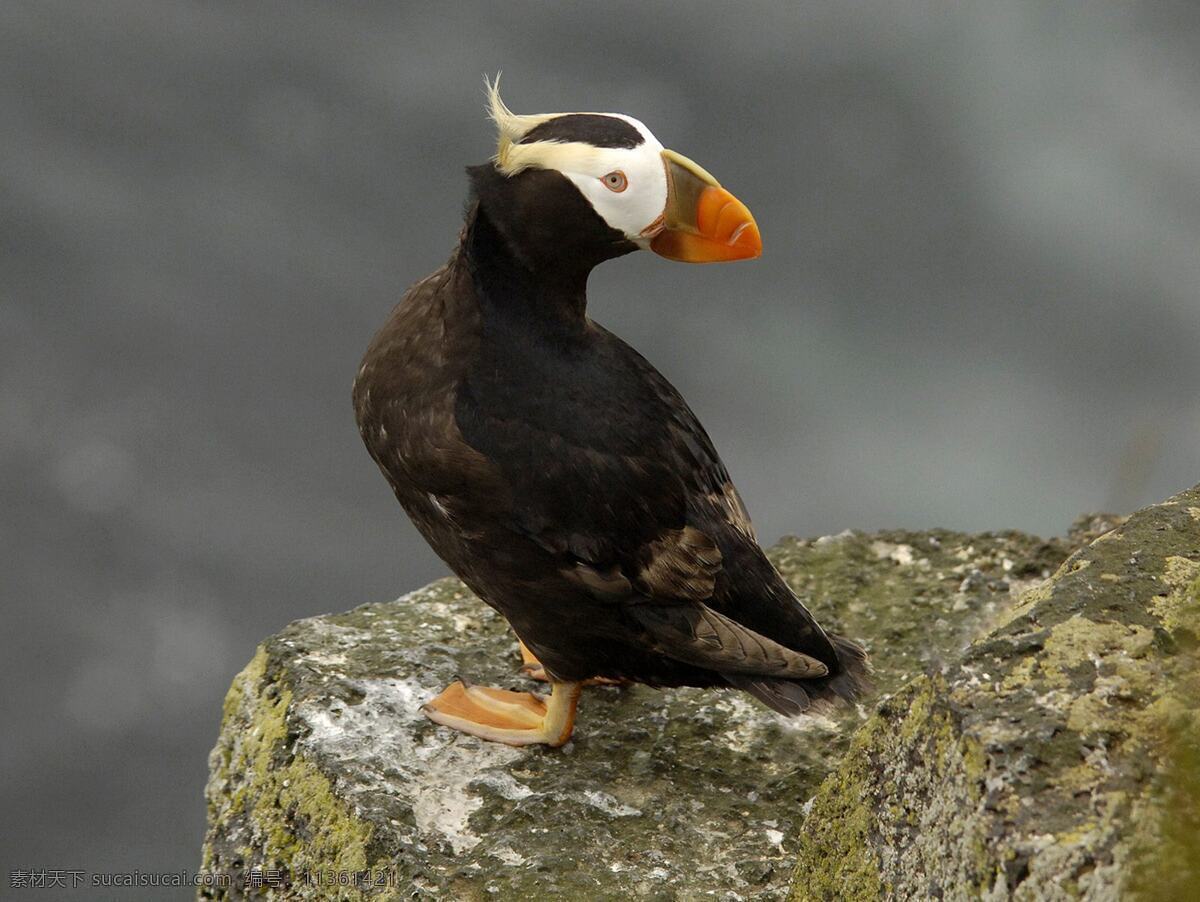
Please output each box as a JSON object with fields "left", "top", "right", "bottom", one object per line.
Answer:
{"left": 475, "top": 82, "right": 762, "bottom": 271}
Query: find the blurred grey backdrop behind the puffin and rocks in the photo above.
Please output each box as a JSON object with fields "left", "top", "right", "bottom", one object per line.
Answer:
{"left": 0, "top": 0, "right": 1200, "bottom": 898}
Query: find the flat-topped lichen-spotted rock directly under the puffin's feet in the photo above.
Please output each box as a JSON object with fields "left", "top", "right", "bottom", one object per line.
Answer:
{"left": 200, "top": 530, "right": 1069, "bottom": 900}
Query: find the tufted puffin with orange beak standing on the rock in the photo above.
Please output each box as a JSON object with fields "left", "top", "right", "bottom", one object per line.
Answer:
{"left": 354, "top": 83, "right": 868, "bottom": 746}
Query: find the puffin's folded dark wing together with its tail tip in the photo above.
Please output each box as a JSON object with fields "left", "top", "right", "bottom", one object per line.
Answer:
{"left": 456, "top": 327, "right": 863, "bottom": 714}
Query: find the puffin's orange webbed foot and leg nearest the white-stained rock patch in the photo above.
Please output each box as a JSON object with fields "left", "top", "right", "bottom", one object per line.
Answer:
{"left": 421, "top": 680, "right": 582, "bottom": 746}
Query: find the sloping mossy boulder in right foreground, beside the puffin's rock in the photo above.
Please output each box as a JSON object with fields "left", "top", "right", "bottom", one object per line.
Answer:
{"left": 792, "top": 487, "right": 1200, "bottom": 900}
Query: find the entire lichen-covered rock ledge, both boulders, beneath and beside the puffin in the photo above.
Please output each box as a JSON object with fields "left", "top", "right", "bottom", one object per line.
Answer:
{"left": 202, "top": 492, "right": 1200, "bottom": 900}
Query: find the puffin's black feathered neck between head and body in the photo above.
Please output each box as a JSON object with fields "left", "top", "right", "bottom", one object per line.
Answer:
{"left": 461, "top": 203, "right": 592, "bottom": 336}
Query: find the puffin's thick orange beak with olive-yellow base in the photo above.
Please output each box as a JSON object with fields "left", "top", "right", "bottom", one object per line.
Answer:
{"left": 644, "top": 150, "right": 762, "bottom": 263}
